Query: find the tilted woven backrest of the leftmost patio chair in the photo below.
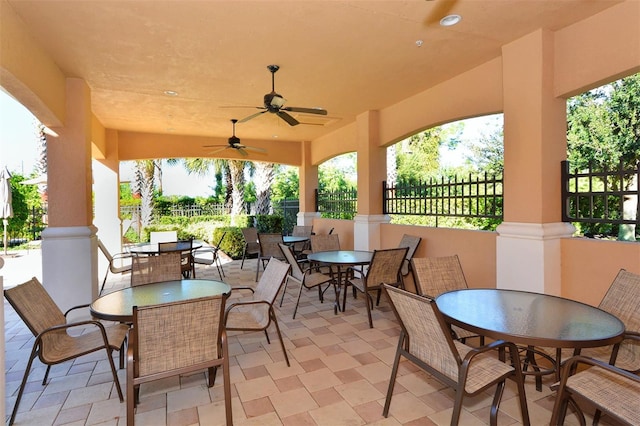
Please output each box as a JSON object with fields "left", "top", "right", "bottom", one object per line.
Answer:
{"left": 4, "top": 277, "right": 67, "bottom": 336}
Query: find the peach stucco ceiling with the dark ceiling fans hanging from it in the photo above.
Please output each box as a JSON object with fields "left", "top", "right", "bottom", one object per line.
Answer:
{"left": 9, "top": 0, "right": 619, "bottom": 145}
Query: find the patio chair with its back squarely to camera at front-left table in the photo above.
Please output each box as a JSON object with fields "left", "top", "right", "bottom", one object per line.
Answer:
{"left": 127, "top": 294, "right": 233, "bottom": 426}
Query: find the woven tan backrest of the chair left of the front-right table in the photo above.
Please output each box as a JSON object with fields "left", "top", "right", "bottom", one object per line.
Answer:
{"left": 383, "top": 285, "right": 462, "bottom": 382}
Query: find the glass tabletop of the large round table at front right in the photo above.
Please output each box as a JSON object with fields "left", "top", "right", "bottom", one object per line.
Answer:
{"left": 436, "top": 289, "right": 624, "bottom": 349}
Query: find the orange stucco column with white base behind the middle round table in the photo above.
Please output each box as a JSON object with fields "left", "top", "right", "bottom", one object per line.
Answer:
{"left": 353, "top": 111, "right": 391, "bottom": 250}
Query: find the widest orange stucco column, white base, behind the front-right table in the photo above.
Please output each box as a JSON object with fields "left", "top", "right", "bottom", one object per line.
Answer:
{"left": 496, "top": 30, "right": 573, "bottom": 294}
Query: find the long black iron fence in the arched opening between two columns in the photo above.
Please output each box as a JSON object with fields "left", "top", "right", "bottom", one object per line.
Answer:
{"left": 382, "top": 173, "right": 504, "bottom": 220}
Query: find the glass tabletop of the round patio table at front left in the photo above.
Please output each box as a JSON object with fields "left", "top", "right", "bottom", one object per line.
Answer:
{"left": 89, "top": 279, "right": 231, "bottom": 322}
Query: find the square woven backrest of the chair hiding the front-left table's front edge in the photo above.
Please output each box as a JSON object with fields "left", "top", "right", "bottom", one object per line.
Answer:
{"left": 130, "top": 295, "right": 226, "bottom": 377}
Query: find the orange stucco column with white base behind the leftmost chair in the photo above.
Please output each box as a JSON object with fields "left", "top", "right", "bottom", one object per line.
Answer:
{"left": 42, "top": 78, "right": 98, "bottom": 311}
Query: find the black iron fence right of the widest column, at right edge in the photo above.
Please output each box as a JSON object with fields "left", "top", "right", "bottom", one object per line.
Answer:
{"left": 561, "top": 161, "right": 640, "bottom": 228}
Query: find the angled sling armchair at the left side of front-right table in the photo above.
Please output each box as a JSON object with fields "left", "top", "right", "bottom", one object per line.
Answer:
{"left": 382, "top": 284, "right": 530, "bottom": 426}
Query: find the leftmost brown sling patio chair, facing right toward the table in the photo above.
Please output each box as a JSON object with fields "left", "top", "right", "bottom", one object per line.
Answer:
{"left": 4, "top": 277, "right": 129, "bottom": 425}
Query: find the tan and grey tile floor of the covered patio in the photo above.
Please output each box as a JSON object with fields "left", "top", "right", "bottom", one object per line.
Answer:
{"left": 4, "top": 255, "right": 611, "bottom": 426}
